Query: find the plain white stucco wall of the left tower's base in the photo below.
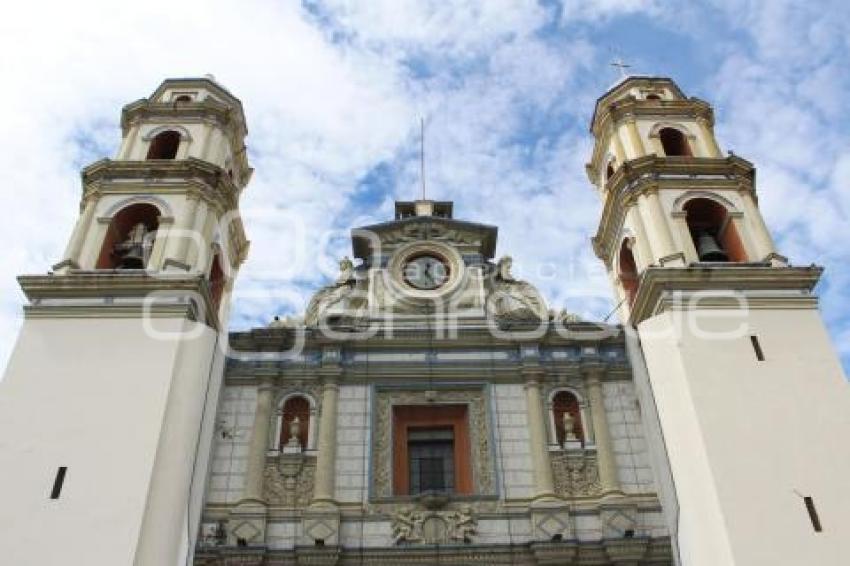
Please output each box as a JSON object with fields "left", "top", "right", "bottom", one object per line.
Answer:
{"left": 0, "top": 319, "right": 220, "bottom": 566}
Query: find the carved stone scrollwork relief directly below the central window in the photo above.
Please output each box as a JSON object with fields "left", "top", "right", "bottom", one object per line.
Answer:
{"left": 392, "top": 505, "right": 478, "bottom": 544}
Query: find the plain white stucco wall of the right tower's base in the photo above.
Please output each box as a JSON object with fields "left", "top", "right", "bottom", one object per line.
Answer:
{"left": 640, "top": 308, "right": 850, "bottom": 566}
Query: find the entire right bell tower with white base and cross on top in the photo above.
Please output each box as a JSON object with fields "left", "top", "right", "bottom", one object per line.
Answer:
{"left": 587, "top": 77, "right": 850, "bottom": 566}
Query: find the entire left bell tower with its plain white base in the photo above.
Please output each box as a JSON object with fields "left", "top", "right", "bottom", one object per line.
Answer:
{"left": 0, "top": 76, "right": 252, "bottom": 566}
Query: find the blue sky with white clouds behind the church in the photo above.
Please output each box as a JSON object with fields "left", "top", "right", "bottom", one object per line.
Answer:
{"left": 0, "top": 0, "right": 850, "bottom": 378}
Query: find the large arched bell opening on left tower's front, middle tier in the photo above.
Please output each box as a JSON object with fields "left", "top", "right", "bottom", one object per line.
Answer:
{"left": 95, "top": 203, "right": 159, "bottom": 269}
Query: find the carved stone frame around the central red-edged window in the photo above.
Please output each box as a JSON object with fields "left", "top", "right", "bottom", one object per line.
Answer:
{"left": 372, "top": 388, "right": 496, "bottom": 498}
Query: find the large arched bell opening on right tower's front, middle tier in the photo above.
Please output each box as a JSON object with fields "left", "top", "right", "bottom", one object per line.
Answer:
{"left": 682, "top": 198, "right": 747, "bottom": 262}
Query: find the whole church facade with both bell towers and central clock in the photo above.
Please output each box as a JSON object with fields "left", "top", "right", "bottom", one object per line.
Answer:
{"left": 0, "top": 77, "right": 850, "bottom": 566}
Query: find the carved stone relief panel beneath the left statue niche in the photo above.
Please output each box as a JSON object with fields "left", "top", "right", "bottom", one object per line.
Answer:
{"left": 263, "top": 454, "right": 316, "bottom": 507}
